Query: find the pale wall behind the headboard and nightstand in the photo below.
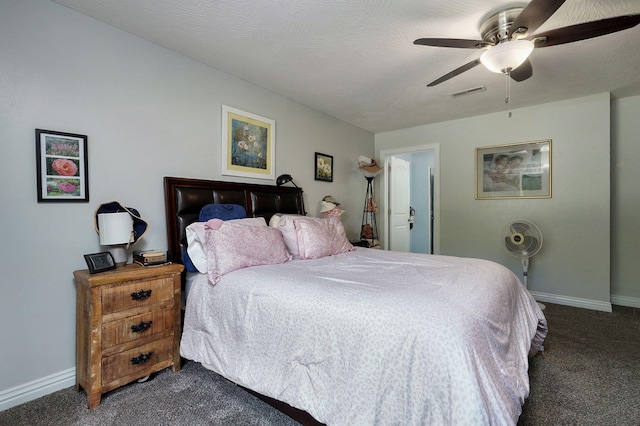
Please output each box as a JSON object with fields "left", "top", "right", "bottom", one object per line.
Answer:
{"left": 0, "top": 0, "right": 374, "bottom": 409}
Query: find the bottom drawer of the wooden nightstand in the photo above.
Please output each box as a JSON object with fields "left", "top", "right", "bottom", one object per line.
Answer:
{"left": 102, "top": 337, "right": 173, "bottom": 385}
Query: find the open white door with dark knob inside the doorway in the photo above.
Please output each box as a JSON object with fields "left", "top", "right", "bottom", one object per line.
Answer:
{"left": 389, "top": 155, "right": 411, "bottom": 252}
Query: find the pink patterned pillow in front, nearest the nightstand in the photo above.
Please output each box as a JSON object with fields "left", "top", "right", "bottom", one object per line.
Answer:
{"left": 205, "top": 219, "right": 291, "bottom": 284}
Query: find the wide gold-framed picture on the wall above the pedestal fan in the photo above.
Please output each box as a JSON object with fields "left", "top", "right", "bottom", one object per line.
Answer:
{"left": 475, "top": 139, "right": 551, "bottom": 200}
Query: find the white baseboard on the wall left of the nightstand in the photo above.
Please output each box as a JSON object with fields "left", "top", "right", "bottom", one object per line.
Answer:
{"left": 0, "top": 367, "right": 76, "bottom": 411}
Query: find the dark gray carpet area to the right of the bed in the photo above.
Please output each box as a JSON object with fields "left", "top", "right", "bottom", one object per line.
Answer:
{"left": 518, "top": 304, "right": 640, "bottom": 426}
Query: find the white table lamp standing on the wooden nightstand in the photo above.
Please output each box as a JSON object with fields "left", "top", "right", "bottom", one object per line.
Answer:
{"left": 98, "top": 212, "right": 134, "bottom": 266}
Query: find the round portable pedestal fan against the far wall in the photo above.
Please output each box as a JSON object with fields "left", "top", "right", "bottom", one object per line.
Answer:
{"left": 501, "top": 220, "right": 544, "bottom": 309}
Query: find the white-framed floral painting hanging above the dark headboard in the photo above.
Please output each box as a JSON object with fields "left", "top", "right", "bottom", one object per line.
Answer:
{"left": 222, "top": 105, "right": 276, "bottom": 179}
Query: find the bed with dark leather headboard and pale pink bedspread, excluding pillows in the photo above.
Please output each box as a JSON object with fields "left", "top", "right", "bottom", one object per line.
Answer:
{"left": 164, "top": 177, "right": 547, "bottom": 425}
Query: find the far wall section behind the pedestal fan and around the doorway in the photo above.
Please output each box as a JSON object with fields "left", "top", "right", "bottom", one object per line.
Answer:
{"left": 375, "top": 94, "right": 610, "bottom": 310}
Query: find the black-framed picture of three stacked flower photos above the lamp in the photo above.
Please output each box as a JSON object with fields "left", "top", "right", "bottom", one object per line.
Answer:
{"left": 36, "top": 129, "right": 89, "bottom": 203}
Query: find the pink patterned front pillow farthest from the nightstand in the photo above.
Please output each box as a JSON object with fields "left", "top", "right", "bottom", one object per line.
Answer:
{"left": 293, "top": 217, "right": 353, "bottom": 259}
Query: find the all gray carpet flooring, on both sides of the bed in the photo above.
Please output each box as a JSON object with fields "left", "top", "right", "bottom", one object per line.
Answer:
{"left": 0, "top": 304, "right": 640, "bottom": 426}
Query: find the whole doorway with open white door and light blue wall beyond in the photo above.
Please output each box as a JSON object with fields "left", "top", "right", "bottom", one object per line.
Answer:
{"left": 380, "top": 144, "right": 440, "bottom": 253}
